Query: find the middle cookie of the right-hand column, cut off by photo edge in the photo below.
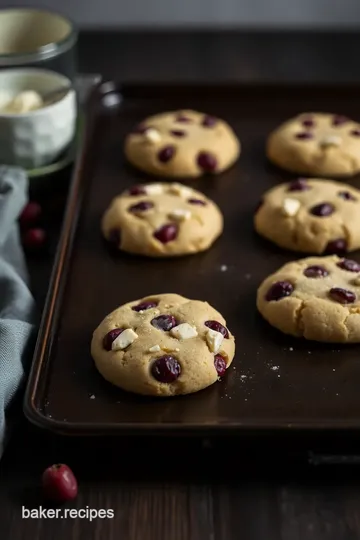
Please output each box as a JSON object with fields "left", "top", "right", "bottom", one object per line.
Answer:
{"left": 254, "top": 178, "right": 360, "bottom": 255}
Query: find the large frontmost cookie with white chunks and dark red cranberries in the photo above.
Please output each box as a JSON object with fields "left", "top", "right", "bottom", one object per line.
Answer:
{"left": 91, "top": 294, "right": 235, "bottom": 396}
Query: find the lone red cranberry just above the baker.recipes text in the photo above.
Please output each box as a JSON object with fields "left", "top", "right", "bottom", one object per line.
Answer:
{"left": 42, "top": 463, "right": 78, "bottom": 502}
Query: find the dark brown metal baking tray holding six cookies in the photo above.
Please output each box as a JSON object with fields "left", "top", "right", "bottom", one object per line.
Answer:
{"left": 24, "top": 82, "right": 360, "bottom": 437}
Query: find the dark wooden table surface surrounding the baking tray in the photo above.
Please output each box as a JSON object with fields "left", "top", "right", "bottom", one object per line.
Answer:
{"left": 0, "top": 32, "right": 360, "bottom": 540}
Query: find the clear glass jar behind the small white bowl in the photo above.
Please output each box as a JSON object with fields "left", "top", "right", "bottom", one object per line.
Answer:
{"left": 0, "top": 8, "right": 78, "bottom": 81}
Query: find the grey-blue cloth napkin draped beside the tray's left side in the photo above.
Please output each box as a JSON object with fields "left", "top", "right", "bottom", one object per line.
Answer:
{"left": 0, "top": 166, "right": 36, "bottom": 457}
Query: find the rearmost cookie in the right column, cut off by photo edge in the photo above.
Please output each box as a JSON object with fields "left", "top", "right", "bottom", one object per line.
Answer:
{"left": 266, "top": 113, "right": 360, "bottom": 176}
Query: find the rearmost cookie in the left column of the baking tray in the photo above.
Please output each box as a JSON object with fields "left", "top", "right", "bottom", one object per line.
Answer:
{"left": 125, "top": 110, "right": 240, "bottom": 178}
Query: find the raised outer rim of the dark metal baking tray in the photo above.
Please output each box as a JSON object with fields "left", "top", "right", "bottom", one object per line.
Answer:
{"left": 23, "top": 79, "right": 360, "bottom": 437}
